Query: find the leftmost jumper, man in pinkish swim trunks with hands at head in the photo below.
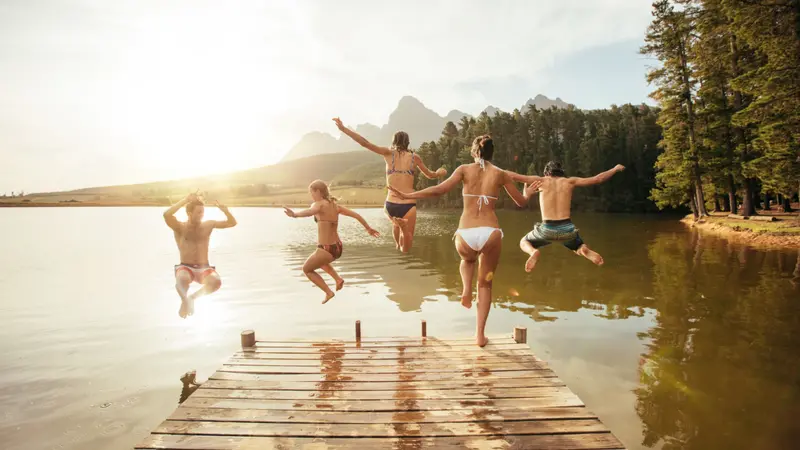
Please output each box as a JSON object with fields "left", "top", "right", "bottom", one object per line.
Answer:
{"left": 164, "top": 194, "right": 236, "bottom": 319}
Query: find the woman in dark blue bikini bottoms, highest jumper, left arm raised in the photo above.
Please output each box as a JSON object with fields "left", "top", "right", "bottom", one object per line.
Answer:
{"left": 333, "top": 117, "right": 447, "bottom": 253}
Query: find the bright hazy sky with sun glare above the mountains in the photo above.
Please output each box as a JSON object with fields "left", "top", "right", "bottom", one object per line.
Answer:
{"left": 0, "top": 0, "right": 653, "bottom": 193}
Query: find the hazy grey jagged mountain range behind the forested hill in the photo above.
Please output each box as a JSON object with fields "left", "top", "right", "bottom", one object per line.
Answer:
{"left": 281, "top": 94, "right": 572, "bottom": 162}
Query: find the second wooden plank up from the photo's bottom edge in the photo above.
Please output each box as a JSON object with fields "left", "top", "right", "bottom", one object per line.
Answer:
{"left": 153, "top": 419, "right": 608, "bottom": 438}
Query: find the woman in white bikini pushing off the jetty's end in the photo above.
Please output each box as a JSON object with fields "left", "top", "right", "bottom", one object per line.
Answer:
{"left": 389, "top": 135, "right": 538, "bottom": 347}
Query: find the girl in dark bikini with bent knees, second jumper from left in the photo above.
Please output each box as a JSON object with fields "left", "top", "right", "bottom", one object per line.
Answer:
{"left": 283, "top": 180, "right": 380, "bottom": 304}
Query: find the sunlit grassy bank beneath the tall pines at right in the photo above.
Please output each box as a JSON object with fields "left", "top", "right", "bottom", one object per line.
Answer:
{"left": 681, "top": 215, "right": 800, "bottom": 249}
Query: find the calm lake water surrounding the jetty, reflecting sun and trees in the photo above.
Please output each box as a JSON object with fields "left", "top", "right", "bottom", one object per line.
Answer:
{"left": 0, "top": 208, "right": 800, "bottom": 450}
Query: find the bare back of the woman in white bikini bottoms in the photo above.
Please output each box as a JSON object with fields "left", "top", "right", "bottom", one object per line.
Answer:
{"left": 458, "top": 162, "right": 508, "bottom": 228}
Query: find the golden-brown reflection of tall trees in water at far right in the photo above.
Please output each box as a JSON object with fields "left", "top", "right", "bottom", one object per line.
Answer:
{"left": 635, "top": 234, "right": 800, "bottom": 449}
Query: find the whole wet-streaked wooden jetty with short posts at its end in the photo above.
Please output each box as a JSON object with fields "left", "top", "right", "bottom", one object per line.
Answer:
{"left": 135, "top": 321, "right": 623, "bottom": 450}
